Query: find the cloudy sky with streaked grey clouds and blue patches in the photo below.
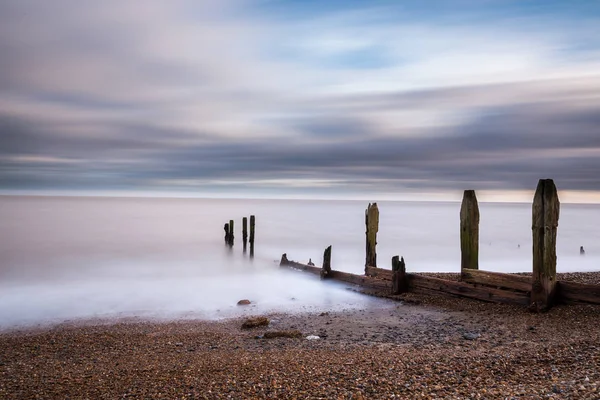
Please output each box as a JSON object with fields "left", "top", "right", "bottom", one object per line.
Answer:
{"left": 0, "top": 0, "right": 600, "bottom": 202}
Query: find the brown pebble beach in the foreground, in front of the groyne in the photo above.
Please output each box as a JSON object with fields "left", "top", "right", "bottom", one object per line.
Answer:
{"left": 0, "top": 294, "right": 600, "bottom": 399}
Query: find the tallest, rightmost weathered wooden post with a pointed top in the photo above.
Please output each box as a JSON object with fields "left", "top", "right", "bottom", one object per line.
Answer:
{"left": 530, "top": 179, "right": 560, "bottom": 311}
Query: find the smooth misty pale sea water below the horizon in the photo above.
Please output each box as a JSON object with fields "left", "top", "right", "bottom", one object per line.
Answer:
{"left": 0, "top": 196, "right": 600, "bottom": 327}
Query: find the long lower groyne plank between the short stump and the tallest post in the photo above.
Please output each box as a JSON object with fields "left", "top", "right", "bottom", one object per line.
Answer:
{"left": 406, "top": 274, "right": 529, "bottom": 305}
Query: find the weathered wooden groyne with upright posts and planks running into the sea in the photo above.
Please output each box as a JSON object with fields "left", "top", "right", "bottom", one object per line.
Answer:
{"left": 280, "top": 179, "right": 600, "bottom": 312}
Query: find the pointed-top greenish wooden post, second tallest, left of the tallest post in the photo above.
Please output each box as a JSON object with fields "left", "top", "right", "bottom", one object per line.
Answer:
{"left": 460, "top": 190, "right": 479, "bottom": 270}
